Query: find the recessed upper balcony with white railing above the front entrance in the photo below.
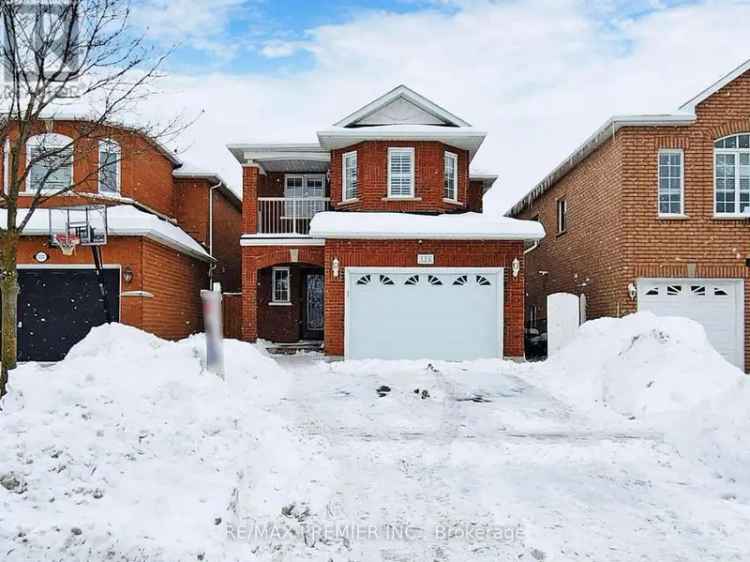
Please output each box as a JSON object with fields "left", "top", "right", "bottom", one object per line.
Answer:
{"left": 258, "top": 197, "right": 331, "bottom": 236}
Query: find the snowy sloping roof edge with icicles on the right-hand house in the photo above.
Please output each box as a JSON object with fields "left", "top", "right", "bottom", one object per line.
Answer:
{"left": 507, "top": 59, "right": 750, "bottom": 216}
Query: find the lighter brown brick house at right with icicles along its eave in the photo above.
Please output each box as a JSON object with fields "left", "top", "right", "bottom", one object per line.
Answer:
{"left": 509, "top": 61, "right": 750, "bottom": 368}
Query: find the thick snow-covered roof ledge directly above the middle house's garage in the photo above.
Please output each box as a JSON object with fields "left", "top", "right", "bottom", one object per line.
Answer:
{"left": 310, "top": 211, "right": 544, "bottom": 240}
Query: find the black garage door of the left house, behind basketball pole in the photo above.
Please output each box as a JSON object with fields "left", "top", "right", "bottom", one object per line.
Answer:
{"left": 18, "top": 269, "right": 120, "bottom": 361}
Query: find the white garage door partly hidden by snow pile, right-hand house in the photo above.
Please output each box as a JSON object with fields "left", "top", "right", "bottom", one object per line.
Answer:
{"left": 638, "top": 279, "right": 745, "bottom": 368}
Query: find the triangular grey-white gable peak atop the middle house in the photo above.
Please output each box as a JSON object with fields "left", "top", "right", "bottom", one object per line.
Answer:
{"left": 333, "top": 84, "right": 471, "bottom": 128}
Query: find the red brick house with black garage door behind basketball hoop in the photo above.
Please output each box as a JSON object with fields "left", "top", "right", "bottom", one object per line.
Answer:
{"left": 0, "top": 119, "right": 242, "bottom": 360}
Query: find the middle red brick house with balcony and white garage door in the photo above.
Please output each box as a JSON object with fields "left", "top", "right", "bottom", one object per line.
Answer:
{"left": 229, "top": 86, "right": 544, "bottom": 359}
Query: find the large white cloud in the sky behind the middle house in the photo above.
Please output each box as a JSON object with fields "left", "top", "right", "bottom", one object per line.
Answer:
{"left": 138, "top": 0, "right": 750, "bottom": 214}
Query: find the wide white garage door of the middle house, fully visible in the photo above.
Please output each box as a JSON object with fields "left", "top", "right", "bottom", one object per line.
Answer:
{"left": 345, "top": 268, "right": 503, "bottom": 360}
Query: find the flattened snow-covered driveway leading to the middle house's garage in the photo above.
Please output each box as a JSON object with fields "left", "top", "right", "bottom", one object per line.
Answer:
{"left": 277, "top": 356, "right": 750, "bottom": 562}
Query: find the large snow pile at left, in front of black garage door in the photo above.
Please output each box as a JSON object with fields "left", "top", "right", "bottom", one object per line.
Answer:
{"left": 0, "top": 324, "right": 328, "bottom": 560}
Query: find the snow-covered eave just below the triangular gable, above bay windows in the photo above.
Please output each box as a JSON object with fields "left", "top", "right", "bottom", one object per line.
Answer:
{"left": 318, "top": 125, "right": 487, "bottom": 158}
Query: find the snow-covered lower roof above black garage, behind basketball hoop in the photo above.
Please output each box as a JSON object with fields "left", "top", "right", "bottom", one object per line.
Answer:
{"left": 5, "top": 205, "right": 211, "bottom": 261}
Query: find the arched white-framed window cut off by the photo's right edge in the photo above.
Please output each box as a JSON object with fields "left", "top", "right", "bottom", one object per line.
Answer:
{"left": 714, "top": 133, "right": 750, "bottom": 215}
